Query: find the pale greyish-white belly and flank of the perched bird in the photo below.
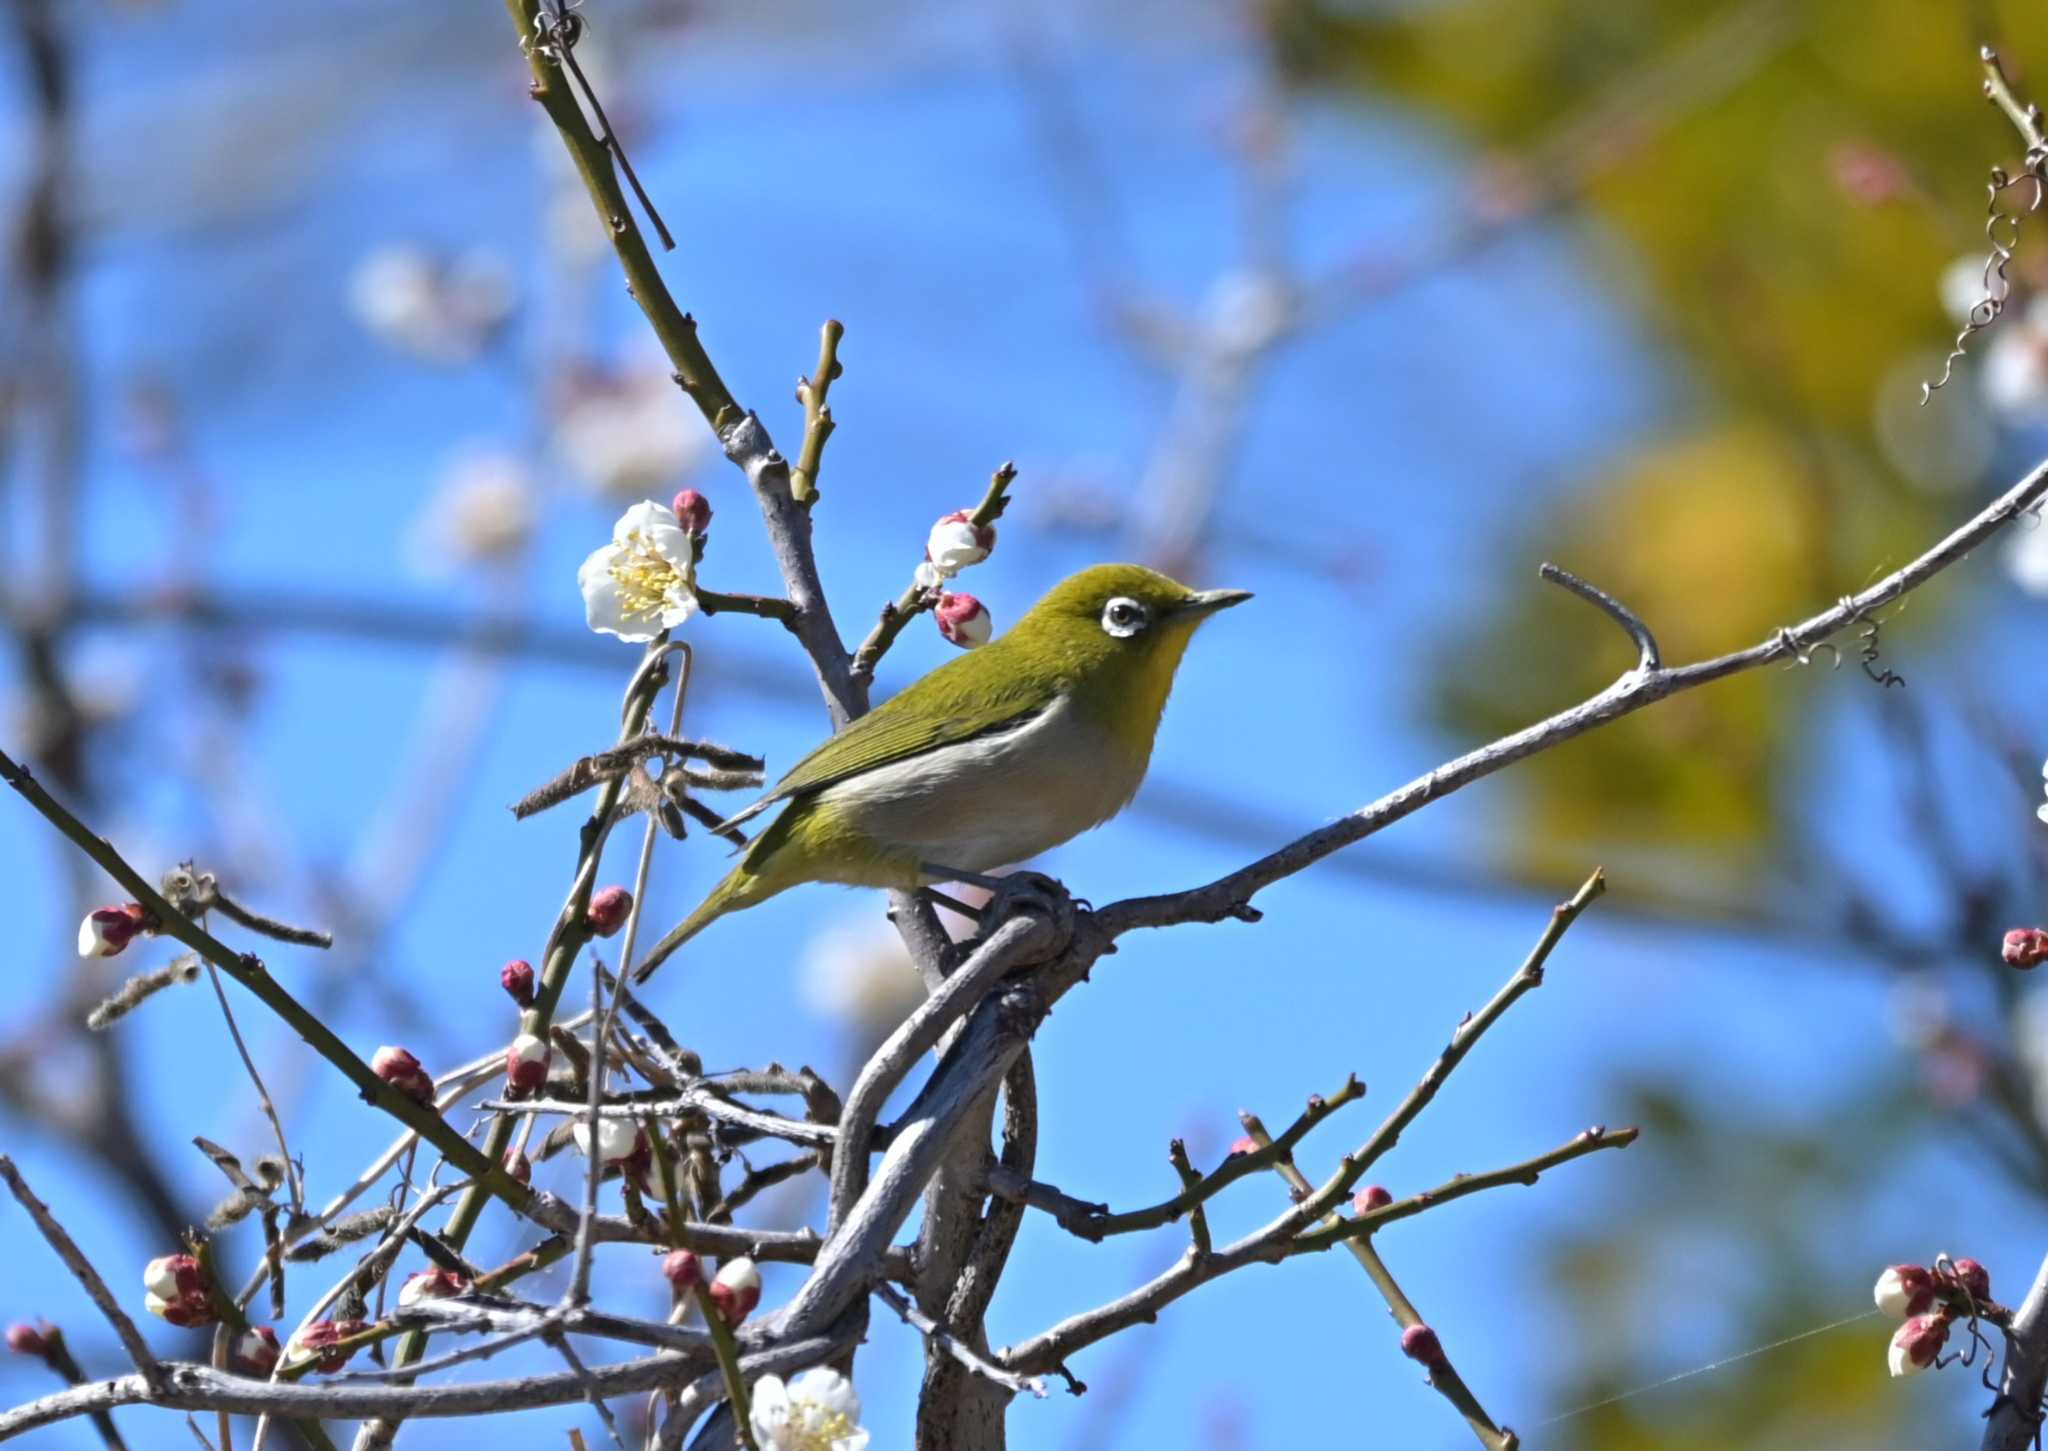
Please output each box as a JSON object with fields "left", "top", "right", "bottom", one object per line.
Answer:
{"left": 819, "top": 699, "right": 1145, "bottom": 871}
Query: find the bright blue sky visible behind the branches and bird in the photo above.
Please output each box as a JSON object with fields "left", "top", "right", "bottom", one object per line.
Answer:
{"left": 0, "top": 4, "right": 2034, "bottom": 1449}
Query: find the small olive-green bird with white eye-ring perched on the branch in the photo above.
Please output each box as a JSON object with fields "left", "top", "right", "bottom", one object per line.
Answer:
{"left": 639, "top": 564, "right": 1251, "bottom": 976}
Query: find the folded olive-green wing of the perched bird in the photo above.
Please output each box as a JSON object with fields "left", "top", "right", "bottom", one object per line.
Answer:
{"left": 719, "top": 646, "right": 1055, "bottom": 830}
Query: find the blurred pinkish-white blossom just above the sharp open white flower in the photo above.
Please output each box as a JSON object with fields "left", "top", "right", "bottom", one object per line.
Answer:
{"left": 553, "top": 365, "right": 707, "bottom": 498}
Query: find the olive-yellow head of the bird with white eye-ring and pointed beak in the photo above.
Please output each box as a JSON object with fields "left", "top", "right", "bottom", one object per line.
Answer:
{"left": 1006, "top": 564, "right": 1251, "bottom": 723}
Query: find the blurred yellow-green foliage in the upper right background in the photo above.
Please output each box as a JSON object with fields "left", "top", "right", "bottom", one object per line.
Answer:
{"left": 1268, "top": 0, "right": 2048, "bottom": 889}
